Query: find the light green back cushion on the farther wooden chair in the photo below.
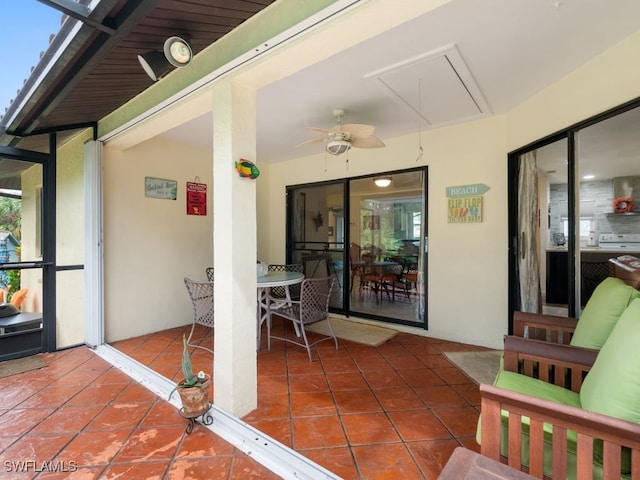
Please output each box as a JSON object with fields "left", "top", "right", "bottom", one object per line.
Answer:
{"left": 571, "top": 277, "right": 640, "bottom": 350}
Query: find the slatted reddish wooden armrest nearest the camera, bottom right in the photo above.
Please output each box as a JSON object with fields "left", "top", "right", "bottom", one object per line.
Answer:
{"left": 480, "top": 384, "right": 640, "bottom": 479}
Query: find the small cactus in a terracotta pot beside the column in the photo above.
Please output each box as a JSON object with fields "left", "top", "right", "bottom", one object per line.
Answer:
{"left": 169, "top": 335, "right": 211, "bottom": 418}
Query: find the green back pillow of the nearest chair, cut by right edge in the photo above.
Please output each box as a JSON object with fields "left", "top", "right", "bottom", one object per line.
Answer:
{"left": 580, "top": 299, "right": 640, "bottom": 423}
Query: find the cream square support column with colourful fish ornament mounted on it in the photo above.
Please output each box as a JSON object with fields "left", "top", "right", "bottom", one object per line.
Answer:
{"left": 213, "top": 79, "right": 260, "bottom": 417}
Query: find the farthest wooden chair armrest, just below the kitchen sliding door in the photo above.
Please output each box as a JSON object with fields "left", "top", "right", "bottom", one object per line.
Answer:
{"left": 513, "top": 311, "right": 578, "bottom": 345}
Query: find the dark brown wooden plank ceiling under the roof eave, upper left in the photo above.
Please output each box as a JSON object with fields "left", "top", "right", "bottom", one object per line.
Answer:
{"left": 7, "top": 0, "right": 275, "bottom": 151}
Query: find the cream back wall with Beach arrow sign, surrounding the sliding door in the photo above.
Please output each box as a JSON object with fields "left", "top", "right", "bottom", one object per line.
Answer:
{"left": 259, "top": 117, "right": 507, "bottom": 348}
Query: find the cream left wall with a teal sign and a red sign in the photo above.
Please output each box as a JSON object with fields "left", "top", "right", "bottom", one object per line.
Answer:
{"left": 103, "top": 138, "right": 213, "bottom": 342}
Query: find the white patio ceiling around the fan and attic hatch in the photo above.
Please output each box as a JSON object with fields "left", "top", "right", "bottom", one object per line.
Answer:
{"left": 159, "top": 0, "right": 640, "bottom": 167}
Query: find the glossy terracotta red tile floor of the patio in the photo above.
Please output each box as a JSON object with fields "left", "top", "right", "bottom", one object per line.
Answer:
{"left": 0, "top": 319, "right": 490, "bottom": 480}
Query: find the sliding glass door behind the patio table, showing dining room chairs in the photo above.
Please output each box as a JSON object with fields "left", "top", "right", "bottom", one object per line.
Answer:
{"left": 287, "top": 169, "right": 427, "bottom": 327}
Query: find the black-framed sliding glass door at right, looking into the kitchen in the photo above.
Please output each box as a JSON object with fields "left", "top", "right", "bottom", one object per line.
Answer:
{"left": 509, "top": 102, "right": 640, "bottom": 326}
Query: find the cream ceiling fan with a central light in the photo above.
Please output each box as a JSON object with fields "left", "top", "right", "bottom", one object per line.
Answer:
{"left": 298, "top": 108, "right": 384, "bottom": 155}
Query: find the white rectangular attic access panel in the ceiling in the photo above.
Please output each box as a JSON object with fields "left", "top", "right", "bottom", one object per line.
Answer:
{"left": 366, "top": 46, "right": 490, "bottom": 126}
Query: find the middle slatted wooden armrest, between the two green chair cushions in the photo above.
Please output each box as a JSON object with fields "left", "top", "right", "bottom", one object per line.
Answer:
{"left": 504, "top": 336, "right": 598, "bottom": 392}
